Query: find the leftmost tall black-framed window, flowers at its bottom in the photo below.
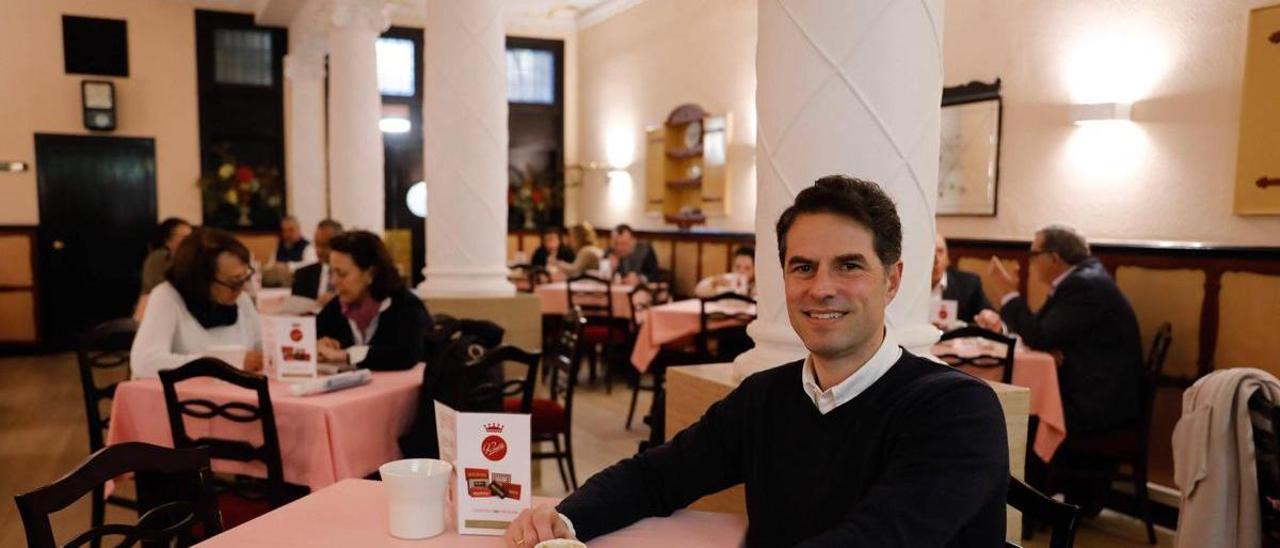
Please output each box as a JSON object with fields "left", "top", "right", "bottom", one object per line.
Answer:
{"left": 196, "top": 10, "right": 288, "bottom": 229}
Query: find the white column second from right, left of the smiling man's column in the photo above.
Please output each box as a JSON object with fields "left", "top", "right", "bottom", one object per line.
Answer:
{"left": 421, "top": 0, "right": 516, "bottom": 297}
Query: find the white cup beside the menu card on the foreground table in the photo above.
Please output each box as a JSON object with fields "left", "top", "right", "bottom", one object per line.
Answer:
{"left": 378, "top": 458, "right": 453, "bottom": 540}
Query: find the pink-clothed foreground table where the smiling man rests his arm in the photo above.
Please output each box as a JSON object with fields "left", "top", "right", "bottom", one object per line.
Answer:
{"left": 197, "top": 479, "right": 746, "bottom": 548}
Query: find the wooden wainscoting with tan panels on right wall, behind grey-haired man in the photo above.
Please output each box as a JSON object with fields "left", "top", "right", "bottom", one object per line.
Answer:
{"left": 947, "top": 239, "right": 1280, "bottom": 488}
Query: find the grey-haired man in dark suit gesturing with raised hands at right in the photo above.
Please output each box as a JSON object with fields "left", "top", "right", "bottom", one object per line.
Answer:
{"left": 977, "top": 224, "right": 1142, "bottom": 435}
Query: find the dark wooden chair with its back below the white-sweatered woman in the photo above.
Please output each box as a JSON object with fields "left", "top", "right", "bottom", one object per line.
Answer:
{"left": 160, "top": 357, "right": 290, "bottom": 529}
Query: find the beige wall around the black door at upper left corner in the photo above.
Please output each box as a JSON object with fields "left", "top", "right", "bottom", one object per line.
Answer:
{"left": 0, "top": 0, "right": 208, "bottom": 224}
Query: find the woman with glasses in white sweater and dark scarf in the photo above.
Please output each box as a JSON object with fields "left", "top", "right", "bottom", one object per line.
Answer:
{"left": 131, "top": 228, "right": 262, "bottom": 379}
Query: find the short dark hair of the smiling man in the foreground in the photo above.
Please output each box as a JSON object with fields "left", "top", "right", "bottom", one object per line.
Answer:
{"left": 777, "top": 175, "right": 902, "bottom": 268}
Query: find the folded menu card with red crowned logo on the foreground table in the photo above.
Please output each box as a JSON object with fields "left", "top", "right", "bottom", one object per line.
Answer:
{"left": 435, "top": 402, "right": 532, "bottom": 535}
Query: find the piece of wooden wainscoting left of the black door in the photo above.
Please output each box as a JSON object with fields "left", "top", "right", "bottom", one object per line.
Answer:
{"left": 0, "top": 225, "right": 40, "bottom": 348}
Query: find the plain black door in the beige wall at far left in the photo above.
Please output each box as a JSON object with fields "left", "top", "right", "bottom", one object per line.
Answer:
{"left": 36, "top": 134, "right": 156, "bottom": 348}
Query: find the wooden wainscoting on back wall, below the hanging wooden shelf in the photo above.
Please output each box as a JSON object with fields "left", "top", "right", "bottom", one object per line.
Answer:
{"left": 507, "top": 228, "right": 755, "bottom": 297}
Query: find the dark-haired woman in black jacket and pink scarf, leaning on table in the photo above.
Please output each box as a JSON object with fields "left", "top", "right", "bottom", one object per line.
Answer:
{"left": 316, "top": 230, "right": 431, "bottom": 371}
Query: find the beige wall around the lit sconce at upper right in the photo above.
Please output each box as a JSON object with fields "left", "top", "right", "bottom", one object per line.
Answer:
{"left": 938, "top": 0, "right": 1280, "bottom": 246}
